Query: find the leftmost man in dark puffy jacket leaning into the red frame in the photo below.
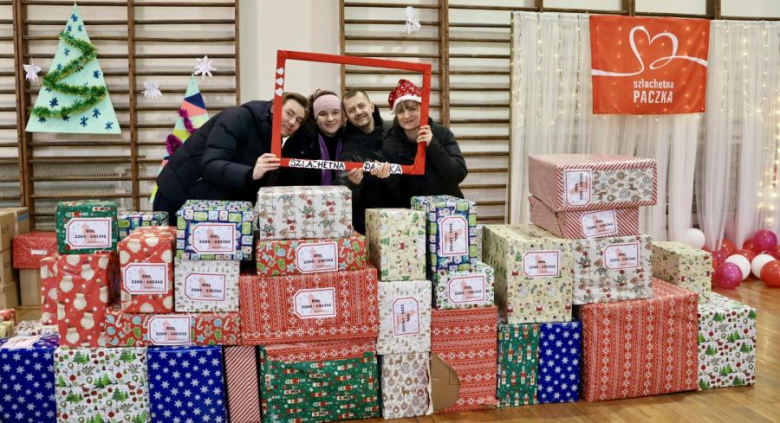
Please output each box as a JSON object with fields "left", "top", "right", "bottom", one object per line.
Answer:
{"left": 153, "top": 93, "right": 307, "bottom": 225}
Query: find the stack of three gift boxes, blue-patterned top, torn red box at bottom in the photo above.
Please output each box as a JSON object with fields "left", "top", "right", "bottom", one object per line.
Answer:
{"left": 412, "top": 196, "right": 497, "bottom": 412}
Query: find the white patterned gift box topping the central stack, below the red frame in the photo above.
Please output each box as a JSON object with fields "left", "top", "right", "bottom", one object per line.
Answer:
{"left": 257, "top": 186, "right": 354, "bottom": 240}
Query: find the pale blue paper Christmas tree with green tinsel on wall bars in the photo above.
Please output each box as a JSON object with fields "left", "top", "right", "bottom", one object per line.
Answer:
{"left": 27, "top": 4, "right": 121, "bottom": 134}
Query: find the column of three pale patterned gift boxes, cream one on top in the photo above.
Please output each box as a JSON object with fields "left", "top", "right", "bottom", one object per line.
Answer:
{"left": 366, "top": 209, "right": 432, "bottom": 419}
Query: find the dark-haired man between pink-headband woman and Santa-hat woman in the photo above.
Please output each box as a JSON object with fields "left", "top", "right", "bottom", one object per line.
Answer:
{"left": 340, "top": 90, "right": 387, "bottom": 234}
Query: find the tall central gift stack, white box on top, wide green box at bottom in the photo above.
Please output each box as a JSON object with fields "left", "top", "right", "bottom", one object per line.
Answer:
{"left": 244, "top": 186, "right": 379, "bottom": 421}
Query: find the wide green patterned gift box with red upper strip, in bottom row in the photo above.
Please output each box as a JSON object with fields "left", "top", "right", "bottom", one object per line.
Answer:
{"left": 260, "top": 339, "right": 379, "bottom": 422}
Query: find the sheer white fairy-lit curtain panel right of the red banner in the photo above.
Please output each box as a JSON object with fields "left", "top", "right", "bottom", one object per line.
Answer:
{"left": 696, "top": 21, "right": 780, "bottom": 248}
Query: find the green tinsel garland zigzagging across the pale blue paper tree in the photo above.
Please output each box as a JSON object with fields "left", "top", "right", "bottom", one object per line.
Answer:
{"left": 31, "top": 31, "right": 108, "bottom": 118}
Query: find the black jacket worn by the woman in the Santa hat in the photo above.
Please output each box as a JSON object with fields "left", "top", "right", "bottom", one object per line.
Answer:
{"left": 383, "top": 119, "right": 468, "bottom": 208}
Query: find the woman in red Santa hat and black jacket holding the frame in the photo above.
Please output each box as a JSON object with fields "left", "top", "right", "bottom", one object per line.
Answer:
{"left": 371, "top": 79, "right": 468, "bottom": 207}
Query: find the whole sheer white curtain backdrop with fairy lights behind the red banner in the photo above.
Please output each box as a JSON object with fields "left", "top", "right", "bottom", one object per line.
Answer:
{"left": 508, "top": 12, "right": 780, "bottom": 245}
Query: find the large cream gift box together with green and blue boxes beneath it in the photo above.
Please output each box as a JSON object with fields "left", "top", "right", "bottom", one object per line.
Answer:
{"left": 483, "top": 225, "right": 581, "bottom": 407}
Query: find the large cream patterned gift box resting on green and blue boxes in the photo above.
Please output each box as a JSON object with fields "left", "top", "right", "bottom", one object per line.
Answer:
{"left": 482, "top": 225, "right": 574, "bottom": 324}
